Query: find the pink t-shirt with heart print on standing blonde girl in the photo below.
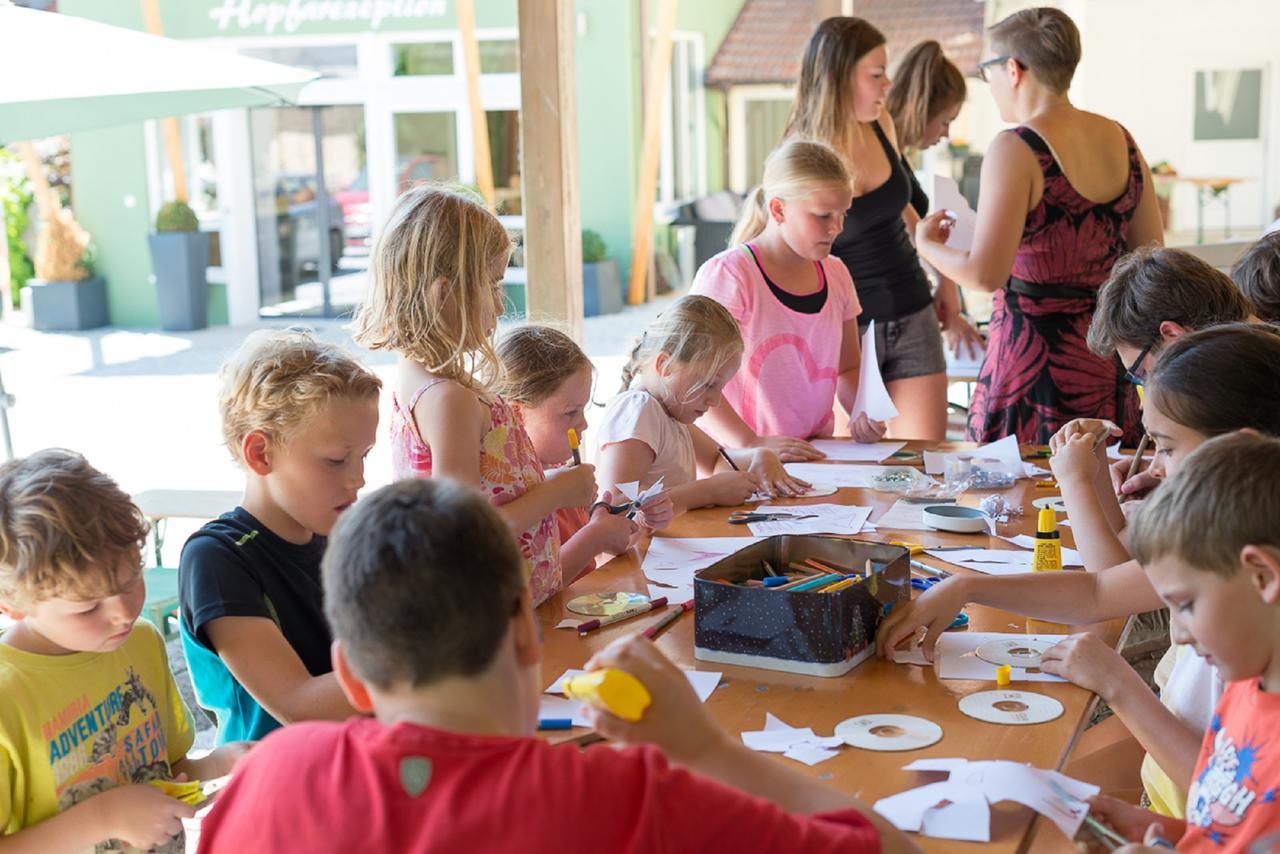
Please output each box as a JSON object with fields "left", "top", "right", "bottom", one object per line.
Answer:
{"left": 690, "top": 246, "right": 861, "bottom": 439}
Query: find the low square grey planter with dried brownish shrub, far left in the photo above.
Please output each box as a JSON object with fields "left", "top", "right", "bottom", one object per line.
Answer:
{"left": 24, "top": 207, "right": 106, "bottom": 332}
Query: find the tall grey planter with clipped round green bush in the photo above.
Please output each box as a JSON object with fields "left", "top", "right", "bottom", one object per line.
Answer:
{"left": 147, "top": 201, "right": 209, "bottom": 332}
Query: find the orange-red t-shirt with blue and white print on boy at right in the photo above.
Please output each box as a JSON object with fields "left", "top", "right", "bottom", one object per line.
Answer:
{"left": 1178, "top": 679, "right": 1280, "bottom": 854}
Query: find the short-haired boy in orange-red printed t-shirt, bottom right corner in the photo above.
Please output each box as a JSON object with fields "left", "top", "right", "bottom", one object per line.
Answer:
{"left": 1091, "top": 433, "right": 1280, "bottom": 853}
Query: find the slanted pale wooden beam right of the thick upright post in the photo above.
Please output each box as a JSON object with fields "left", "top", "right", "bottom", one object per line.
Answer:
{"left": 627, "top": 0, "right": 676, "bottom": 305}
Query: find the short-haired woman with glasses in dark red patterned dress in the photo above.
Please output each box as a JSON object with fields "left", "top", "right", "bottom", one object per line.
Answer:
{"left": 916, "top": 8, "right": 1164, "bottom": 444}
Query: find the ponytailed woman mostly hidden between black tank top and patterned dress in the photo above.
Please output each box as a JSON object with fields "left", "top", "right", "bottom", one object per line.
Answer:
{"left": 886, "top": 41, "right": 983, "bottom": 356}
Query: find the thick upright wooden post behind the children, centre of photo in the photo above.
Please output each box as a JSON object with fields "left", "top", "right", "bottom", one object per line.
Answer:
{"left": 518, "top": 0, "right": 582, "bottom": 341}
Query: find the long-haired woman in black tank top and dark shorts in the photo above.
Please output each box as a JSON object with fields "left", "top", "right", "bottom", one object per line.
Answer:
{"left": 785, "top": 18, "right": 959, "bottom": 440}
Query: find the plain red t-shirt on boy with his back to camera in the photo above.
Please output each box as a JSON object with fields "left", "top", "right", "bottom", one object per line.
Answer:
{"left": 198, "top": 718, "right": 881, "bottom": 854}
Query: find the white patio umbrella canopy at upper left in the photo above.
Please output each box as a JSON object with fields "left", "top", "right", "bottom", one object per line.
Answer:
{"left": 0, "top": 0, "right": 319, "bottom": 143}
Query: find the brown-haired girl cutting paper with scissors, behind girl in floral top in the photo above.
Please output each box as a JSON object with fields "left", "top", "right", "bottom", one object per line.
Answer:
{"left": 498, "top": 325, "right": 671, "bottom": 584}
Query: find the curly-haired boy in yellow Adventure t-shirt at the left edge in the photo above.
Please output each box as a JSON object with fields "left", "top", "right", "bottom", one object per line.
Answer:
{"left": 0, "top": 449, "right": 247, "bottom": 851}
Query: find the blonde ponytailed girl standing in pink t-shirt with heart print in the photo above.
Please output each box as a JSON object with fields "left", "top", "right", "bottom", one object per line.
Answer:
{"left": 690, "top": 140, "right": 884, "bottom": 460}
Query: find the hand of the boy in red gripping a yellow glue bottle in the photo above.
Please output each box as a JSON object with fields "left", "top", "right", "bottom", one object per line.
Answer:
{"left": 586, "top": 635, "right": 728, "bottom": 764}
